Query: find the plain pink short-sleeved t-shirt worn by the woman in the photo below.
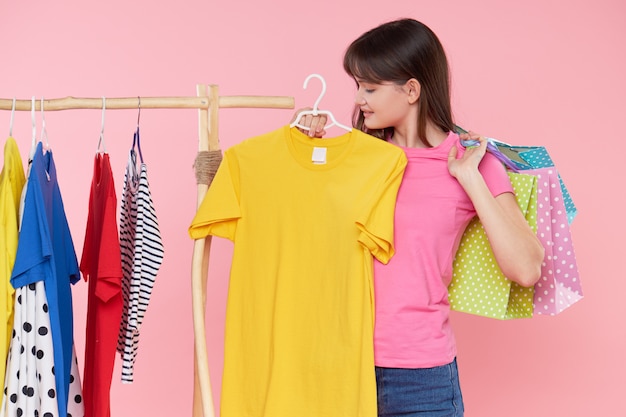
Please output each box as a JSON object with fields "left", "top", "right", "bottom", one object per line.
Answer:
{"left": 374, "top": 133, "right": 513, "bottom": 368}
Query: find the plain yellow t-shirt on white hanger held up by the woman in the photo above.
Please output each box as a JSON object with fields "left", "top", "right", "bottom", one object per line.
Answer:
{"left": 189, "top": 126, "right": 406, "bottom": 417}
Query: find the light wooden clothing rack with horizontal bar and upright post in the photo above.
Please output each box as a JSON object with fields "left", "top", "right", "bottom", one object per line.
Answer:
{"left": 0, "top": 84, "right": 294, "bottom": 417}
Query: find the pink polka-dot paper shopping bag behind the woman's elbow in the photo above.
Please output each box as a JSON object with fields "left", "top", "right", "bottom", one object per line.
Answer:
{"left": 525, "top": 168, "right": 583, "bottom": 315}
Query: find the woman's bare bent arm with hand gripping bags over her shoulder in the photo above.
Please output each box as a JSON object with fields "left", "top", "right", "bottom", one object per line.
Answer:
{"left": 448, "top": 138, "right": 544, "bottom": 287}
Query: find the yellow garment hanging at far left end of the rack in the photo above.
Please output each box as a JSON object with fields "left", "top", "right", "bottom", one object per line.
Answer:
{"left": 0, "top": 137, "right": 26, "bottom": 381}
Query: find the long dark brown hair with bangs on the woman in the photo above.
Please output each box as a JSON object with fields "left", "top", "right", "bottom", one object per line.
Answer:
{"left": 343, "top": 19, "right": 454, "bottom": 146}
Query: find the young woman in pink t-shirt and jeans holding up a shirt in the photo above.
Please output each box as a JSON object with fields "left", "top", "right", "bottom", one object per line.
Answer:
{"left": 292, "top": 19, "right": 544, "bottom": 417}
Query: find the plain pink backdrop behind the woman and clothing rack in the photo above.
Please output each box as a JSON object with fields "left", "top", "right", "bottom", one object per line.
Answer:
{"left": 0, "top": 0, "right": 626, "bottom": 417}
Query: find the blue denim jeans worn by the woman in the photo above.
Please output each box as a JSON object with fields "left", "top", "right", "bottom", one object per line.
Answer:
{"left": 376, "top": 359, "right": 463, "bottom": 417}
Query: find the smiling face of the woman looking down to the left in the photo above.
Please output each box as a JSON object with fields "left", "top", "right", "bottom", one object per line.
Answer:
{"left": 354, "top": 79, "right": 411, "bottom": 129}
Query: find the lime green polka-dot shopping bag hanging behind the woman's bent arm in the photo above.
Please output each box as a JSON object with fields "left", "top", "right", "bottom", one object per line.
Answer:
{"left": 448, "top": 172, "right": 537, "bottom": 320}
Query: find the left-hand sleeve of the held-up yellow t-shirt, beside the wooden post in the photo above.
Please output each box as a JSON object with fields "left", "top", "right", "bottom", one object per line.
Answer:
{"left": 189, "top": 150, "right": 241, "bottom": 241}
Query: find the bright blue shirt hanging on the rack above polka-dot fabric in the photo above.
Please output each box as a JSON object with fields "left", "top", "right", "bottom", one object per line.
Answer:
{"left": 11, "top": 142, "right": 80, "bottom": 416}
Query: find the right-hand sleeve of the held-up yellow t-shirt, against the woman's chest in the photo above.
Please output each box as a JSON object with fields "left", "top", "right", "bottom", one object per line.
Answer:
{"left": 356, "top": 152, "right": 407, "bottom": 264}
